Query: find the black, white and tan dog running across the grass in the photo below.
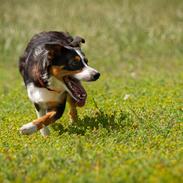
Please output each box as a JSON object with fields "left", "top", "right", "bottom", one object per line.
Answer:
{"left": 19, "top": 31, "right": 100, "bottom": 136}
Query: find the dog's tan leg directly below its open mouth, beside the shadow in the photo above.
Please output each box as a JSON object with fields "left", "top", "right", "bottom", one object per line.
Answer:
{"left": 67, "top": 95, "right": 78, "bottom": 122}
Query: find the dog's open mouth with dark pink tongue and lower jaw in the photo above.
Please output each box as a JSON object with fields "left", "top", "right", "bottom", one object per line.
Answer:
{"left": 63, "top": 76, "right": 87, "bottom": 107}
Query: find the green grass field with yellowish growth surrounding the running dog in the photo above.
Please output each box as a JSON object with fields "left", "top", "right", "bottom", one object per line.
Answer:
{"left": 0, "top": 0, "right": 183, "bottom": 183}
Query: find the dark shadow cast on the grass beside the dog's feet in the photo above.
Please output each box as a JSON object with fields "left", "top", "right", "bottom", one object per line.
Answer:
{"left": 52, "top": 111, "right": 127, "bottom": 135}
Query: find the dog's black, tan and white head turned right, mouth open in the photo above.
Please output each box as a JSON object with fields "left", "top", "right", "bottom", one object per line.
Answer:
{"left": 35, "top": 37, "right": 100, "bottom": 106}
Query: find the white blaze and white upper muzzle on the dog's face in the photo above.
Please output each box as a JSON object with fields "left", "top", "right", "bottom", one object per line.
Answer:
{"left": 73, "top": 49, "right": 98, "bottom": 81}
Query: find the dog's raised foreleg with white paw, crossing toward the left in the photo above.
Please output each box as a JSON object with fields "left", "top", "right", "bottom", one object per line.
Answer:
{"left": 20, "top": 104, "right": 65, "bottom": 135}
